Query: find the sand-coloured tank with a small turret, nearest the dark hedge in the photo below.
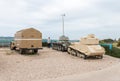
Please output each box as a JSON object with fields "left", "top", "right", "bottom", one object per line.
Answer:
{"left": 68, "top": 34, "right": 105, "bottom": 59}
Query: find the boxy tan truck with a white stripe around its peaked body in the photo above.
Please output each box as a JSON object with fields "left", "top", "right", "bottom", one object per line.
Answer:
{"left": 10, "top": 28, "right": 42, "bottom": 54}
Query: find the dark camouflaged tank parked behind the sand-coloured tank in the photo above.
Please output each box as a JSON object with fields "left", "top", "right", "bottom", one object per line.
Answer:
{"left": 52, "top": 35, "right": 70, "bottom": 51}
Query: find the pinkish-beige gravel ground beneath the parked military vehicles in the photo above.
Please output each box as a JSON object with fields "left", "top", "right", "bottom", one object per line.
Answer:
{"left": 0, "top": 48, "right": 120, "bottom": 81}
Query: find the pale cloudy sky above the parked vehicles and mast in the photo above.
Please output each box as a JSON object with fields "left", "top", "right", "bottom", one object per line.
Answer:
{"left": 0, "top": 0, "right": 120, "bottom": 40}
